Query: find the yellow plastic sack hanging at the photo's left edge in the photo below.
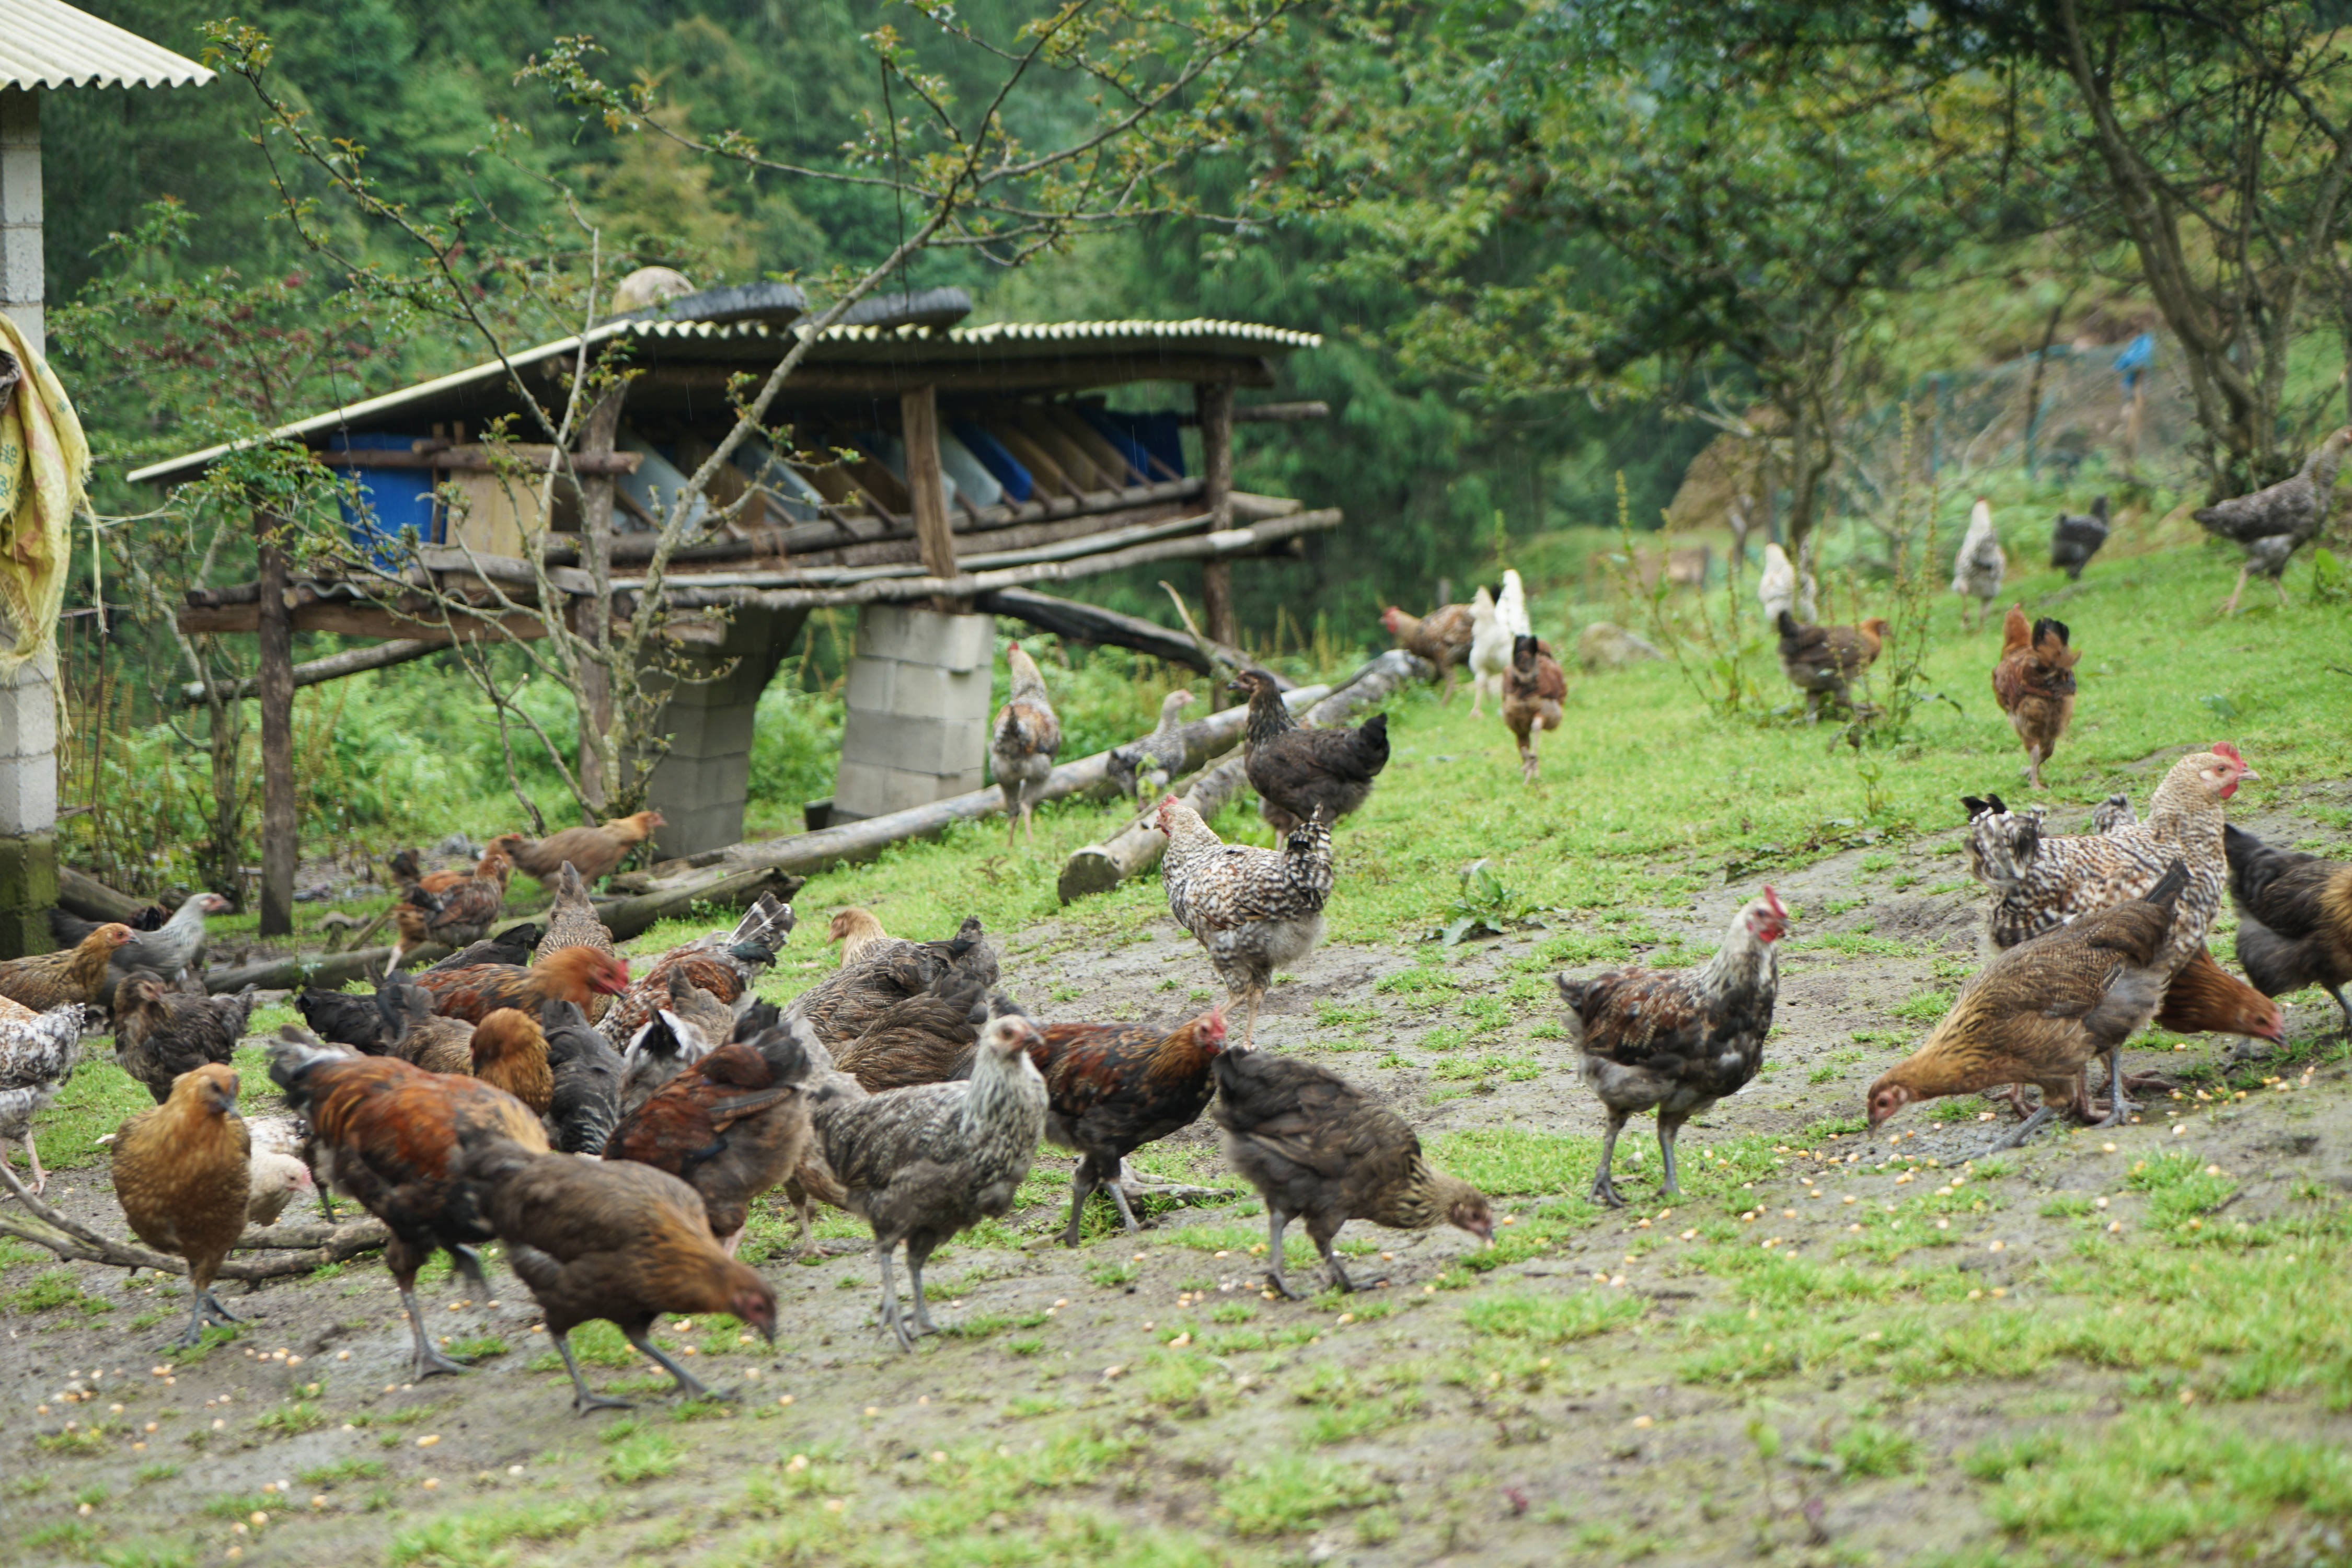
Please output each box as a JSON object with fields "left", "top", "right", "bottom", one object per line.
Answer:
{"left": 0, "top": 315, "right": 89, "bottom": 677}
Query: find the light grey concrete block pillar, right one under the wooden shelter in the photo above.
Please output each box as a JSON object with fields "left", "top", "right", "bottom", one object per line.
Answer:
{"left": 833, "top": 604, "right": 997, "bottom": 823}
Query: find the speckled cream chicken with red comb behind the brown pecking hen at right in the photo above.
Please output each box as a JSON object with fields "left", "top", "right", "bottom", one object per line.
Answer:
{"left": 1962, "top": 741, "right": 2261, "bottom": 981}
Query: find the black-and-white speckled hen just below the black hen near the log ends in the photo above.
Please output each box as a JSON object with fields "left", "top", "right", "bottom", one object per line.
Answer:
{"left": 1160, "top": 794, "right": 1331, "bottom": 1046}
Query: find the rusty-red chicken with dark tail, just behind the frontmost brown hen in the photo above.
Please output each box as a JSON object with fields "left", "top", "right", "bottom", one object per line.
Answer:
{"left": 271, "top": 1025, "right": 548, "bottom": 1382}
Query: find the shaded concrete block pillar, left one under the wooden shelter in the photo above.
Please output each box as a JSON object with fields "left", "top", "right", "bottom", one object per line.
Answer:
{"left": 647, "top": 609, "right": 809, "bottom": 858}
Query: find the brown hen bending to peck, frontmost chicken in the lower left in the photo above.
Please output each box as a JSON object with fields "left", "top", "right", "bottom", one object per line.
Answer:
{"left": 464, "top": 1138, "right": 776, "bottom": 1415}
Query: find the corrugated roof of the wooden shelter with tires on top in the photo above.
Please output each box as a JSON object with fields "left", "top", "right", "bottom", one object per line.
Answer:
{"left": 129, "top": 315, "right": 1322, "bottom": 485}
